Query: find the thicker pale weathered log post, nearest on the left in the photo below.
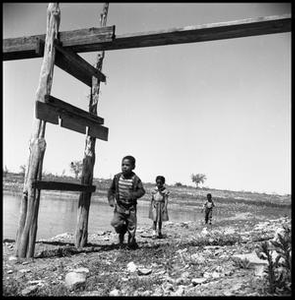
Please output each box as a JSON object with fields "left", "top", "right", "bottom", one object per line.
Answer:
{"left": 15, "top": 3, "right": 60, "bottom": 258}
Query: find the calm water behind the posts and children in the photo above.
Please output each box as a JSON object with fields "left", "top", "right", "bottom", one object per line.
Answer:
{"left": 3, "top": 193, "right": 203, "bottom": 240}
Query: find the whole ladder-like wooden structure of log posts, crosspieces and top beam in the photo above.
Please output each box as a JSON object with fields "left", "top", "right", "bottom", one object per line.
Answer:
{"left": 3, "top": 3, "right": 291, "bottom": 258}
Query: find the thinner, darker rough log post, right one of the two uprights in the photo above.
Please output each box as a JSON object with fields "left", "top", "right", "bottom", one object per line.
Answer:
{"left": 75, "top": 3, "right": 109, "bottom": 248}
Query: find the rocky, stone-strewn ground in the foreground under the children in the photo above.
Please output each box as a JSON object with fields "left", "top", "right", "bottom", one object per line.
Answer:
{"left": 2, "top": 213, "right": 291, "bottom": 296}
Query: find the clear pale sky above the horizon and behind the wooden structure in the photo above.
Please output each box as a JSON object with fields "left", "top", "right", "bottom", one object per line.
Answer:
{"left": 2, "top": 2, "right": 291, "bottom": 194}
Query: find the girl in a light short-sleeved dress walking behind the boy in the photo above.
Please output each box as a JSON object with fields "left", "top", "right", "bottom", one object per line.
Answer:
{"left": 149, "top": 176, "right": 170, "bottom": 238}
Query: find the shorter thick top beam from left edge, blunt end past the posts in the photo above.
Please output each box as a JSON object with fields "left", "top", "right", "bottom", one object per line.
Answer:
{"left": 2, "top": 26, "right": 115, "bottom": 60}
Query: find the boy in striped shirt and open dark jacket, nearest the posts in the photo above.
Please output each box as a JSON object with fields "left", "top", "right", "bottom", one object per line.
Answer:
{"left": 108, "top": 155, "right": 145, "bottom": 249}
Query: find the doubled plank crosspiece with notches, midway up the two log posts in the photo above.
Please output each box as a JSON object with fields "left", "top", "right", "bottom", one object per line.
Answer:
{"left": 35, "top": 95, "right": 109, "bottom": 141}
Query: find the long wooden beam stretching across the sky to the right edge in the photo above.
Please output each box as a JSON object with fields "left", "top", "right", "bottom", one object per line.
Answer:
{"left": 98, "top": 15, "right": 291, "bottom": 51}
